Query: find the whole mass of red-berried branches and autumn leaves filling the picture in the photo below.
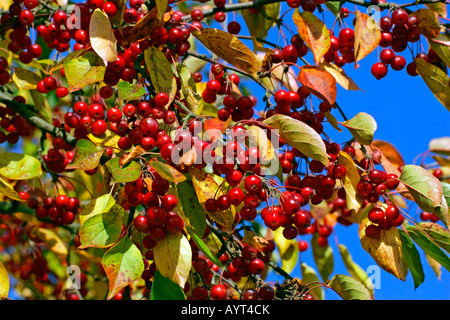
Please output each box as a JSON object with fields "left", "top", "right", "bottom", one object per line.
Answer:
{"left": 0, "top": 0, "right": 450, "bottom": 300}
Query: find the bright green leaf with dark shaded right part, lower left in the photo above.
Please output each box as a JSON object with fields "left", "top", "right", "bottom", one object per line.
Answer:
{"left": 78, "top": 211, "right": 123, "bottom": 249}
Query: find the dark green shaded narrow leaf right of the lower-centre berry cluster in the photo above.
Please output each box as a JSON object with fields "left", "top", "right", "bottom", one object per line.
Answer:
{"left": 176, "top": 181, "right": 206, "bottom": 238}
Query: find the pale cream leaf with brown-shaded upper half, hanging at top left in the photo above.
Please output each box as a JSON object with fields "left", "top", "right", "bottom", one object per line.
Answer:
{"left": 89, "top": 9, "right": 117, "bottom": 66}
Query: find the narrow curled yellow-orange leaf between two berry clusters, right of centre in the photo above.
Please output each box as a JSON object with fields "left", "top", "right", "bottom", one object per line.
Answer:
{"left": 338, "top": 151, "right": 363, "bottom": 211}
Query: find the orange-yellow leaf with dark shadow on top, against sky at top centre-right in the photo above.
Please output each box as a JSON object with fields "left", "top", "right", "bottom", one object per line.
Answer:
{"left": 292, "top": 9, "right": 331, "bottom": 65}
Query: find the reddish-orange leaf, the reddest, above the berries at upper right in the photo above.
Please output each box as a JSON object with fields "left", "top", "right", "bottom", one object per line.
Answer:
{"left": 297, "top": 65, "right": 337, "bottom": 105}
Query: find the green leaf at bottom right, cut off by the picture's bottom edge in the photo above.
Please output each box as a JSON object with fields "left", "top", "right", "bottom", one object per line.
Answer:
{"left": 328, "top": 274, "right": 372, "bottom": 300}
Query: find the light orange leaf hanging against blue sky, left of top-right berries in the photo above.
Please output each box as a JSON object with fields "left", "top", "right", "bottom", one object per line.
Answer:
{"left": 354, "top": 10, "right": 381, "bottom": 63}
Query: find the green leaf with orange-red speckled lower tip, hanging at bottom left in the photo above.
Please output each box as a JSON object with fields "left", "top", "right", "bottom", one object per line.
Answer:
{"left": 102, "top": 236, "right": 144, "bottom": 300}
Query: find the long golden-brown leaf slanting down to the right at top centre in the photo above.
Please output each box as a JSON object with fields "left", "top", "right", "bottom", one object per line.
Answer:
{"left": 193, "top": 28, "right": 258, "bottom": 77}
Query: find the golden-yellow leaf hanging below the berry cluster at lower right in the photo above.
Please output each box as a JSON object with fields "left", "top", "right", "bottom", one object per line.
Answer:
{"left": 359, "top": 220, "right": 406, "bottom": 281}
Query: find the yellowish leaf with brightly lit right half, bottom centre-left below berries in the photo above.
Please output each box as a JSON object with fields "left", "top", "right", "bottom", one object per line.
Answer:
{"left": 153, "top": 233, "right": 192, "bottom": 288}
